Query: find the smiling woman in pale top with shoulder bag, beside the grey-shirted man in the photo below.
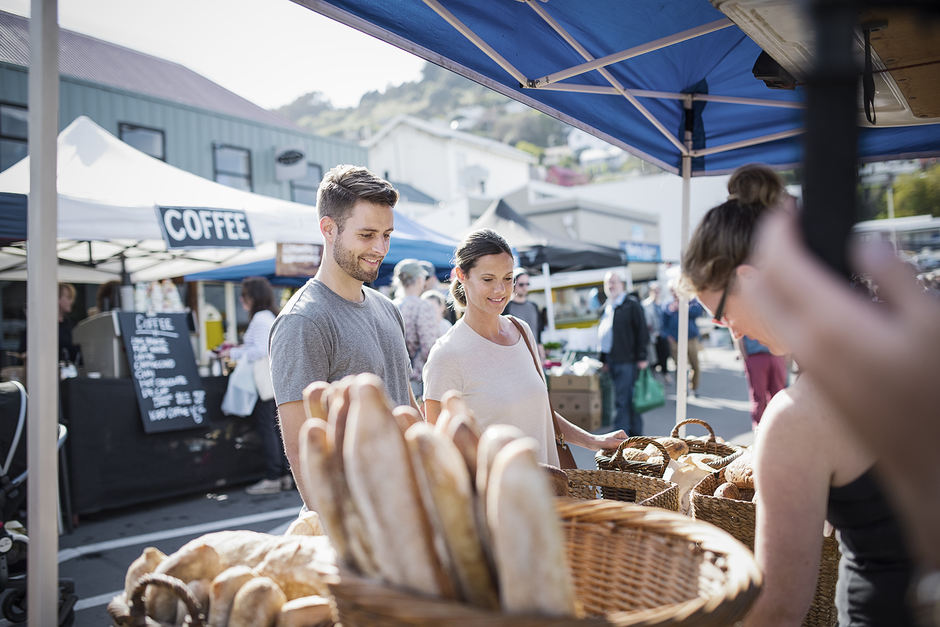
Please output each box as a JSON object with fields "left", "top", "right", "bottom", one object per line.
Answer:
{"left": 424, "top": 229, "right": 626, "bottom": 466}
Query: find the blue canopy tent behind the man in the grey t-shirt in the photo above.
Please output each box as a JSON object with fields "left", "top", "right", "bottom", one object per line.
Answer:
{"left": 184, "top": 211, "right": 457, "bottom": 287}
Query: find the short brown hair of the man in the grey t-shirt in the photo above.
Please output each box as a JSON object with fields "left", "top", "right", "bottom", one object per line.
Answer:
{"left": 317, "top": 165, "right": 398, "bottom": 232}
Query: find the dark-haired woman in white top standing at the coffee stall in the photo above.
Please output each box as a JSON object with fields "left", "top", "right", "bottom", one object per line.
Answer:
{"left": 219, "top": 277, "right": 294, "bottom": 494}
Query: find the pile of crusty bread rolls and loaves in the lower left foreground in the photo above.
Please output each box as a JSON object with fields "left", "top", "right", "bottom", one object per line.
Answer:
{"left": 112, "top": 512, "right": 336, "bottom": 627}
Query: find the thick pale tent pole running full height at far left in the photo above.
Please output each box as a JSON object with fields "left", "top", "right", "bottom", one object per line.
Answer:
{"left": 26, "top": 0, "right": 59, "bottom": 627}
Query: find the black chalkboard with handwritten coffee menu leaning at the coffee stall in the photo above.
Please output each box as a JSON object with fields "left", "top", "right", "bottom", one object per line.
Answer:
{"left": 118, "top": 312, "right": 206, "bottom": 433}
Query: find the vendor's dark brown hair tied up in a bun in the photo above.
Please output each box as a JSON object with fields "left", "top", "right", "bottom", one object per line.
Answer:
{"left": 676, "top": 163, "right": 787, "bottom": 294}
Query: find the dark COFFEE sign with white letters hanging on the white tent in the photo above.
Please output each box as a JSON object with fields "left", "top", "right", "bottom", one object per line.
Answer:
{"left": 157, "top": 207, "right": 255, "bottom": 250}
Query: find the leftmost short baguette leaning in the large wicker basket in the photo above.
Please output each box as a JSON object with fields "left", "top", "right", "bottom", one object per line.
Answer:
{"left": 300, "top": 418, "right": 352, "bottom": 563}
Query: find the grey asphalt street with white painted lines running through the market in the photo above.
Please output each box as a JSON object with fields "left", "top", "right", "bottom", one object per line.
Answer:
{"left": 11, "top": 348, "right": 752, "bottom": 627}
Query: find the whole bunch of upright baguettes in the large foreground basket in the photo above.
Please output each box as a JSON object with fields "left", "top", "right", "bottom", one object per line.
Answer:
{"left": 300, "top": 374, "right": 579, "bottom": 617}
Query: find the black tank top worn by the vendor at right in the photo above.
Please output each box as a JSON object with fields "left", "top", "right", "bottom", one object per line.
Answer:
{"left": 826, "top": 468, "right": 916, "bottom": 627}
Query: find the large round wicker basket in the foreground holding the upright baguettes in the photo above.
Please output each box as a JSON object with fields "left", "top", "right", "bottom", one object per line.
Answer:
{"left": 327, "top": 499, "right": 760, "bottom": 627}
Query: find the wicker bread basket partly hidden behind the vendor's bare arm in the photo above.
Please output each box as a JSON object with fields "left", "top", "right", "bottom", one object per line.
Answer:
{"left": 692, "top": 469, "right": 841, "bottom": 627}
